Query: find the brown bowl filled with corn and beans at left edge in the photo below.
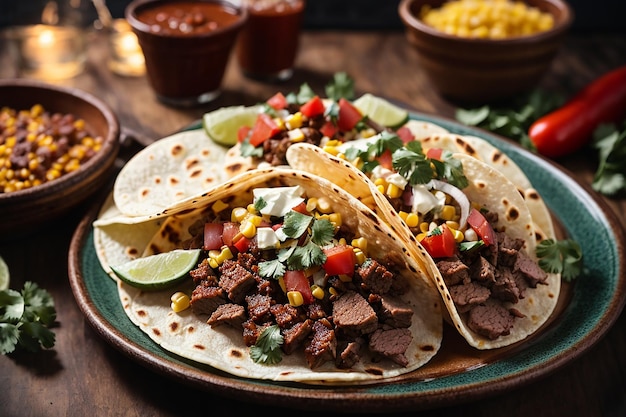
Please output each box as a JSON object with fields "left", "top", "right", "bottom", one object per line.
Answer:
{"left": 0, "top": 79, "right": 120, "bottom": 236}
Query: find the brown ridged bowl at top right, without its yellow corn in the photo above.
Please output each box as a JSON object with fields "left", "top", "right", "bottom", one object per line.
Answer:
{"left": 398, "top": 0, "right": 574, "bottom": 103}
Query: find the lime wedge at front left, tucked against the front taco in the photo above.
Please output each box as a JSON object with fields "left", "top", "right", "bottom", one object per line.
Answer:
{"left": 111, "top": 249, "right": 200, "bottom": 290}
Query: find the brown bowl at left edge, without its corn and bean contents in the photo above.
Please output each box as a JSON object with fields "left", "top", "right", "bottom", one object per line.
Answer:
{"left": 0, "top": 79, "right": 120, "bottom": 236}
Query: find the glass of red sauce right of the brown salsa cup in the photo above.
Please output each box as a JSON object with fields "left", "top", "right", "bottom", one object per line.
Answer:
{"left": 237, "top": 0, "right": 305, "bottom": 82}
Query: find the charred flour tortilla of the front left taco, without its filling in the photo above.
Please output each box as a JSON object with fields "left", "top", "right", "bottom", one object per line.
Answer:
{"left": 96, "top": 169, "right": 443, "bottom": 384}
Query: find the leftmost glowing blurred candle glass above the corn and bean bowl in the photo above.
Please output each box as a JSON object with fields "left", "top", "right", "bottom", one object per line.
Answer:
{"left": 7, "top": 24, "right": 87, "bottom": 80}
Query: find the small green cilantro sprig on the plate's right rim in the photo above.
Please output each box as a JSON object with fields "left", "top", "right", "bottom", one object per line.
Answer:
{"left": 536, "top": 239, "right": 583, "bottom": 281}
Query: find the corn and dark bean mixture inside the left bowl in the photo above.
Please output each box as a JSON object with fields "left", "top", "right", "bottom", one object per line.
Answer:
{"left": 0, "top": 104, "right": 103, "bottom": 193}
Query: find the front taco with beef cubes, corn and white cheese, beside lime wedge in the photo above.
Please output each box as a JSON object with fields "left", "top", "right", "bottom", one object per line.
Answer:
{"left": 95, "top": 169, "right": 443, "bottom": 384}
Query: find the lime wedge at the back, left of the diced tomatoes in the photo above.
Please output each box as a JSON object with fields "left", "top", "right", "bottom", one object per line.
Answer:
{"left": 202, "top": 106, "right": 261, "bottom": 146}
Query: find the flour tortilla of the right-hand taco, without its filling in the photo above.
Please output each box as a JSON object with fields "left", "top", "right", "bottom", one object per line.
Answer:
{"left": 287, "top": 144, "right": 561, "bottom": 349}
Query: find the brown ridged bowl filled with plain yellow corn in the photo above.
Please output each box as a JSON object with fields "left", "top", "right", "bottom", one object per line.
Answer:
{"left": 398, "top": 0, "right": 574, "bottom": 103}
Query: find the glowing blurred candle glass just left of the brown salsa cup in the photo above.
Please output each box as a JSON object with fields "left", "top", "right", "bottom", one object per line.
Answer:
{"left": 107, "top": 19, "right": 146, "bottom": 77}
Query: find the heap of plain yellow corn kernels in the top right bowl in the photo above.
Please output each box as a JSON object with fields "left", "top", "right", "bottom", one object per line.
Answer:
{"left": 420, "top": 0, "right": 554, "bottom": 39}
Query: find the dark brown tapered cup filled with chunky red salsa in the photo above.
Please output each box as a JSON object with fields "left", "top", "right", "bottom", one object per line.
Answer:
{"left": 126, "top": 0, "right": 248, "bottom": 107}
